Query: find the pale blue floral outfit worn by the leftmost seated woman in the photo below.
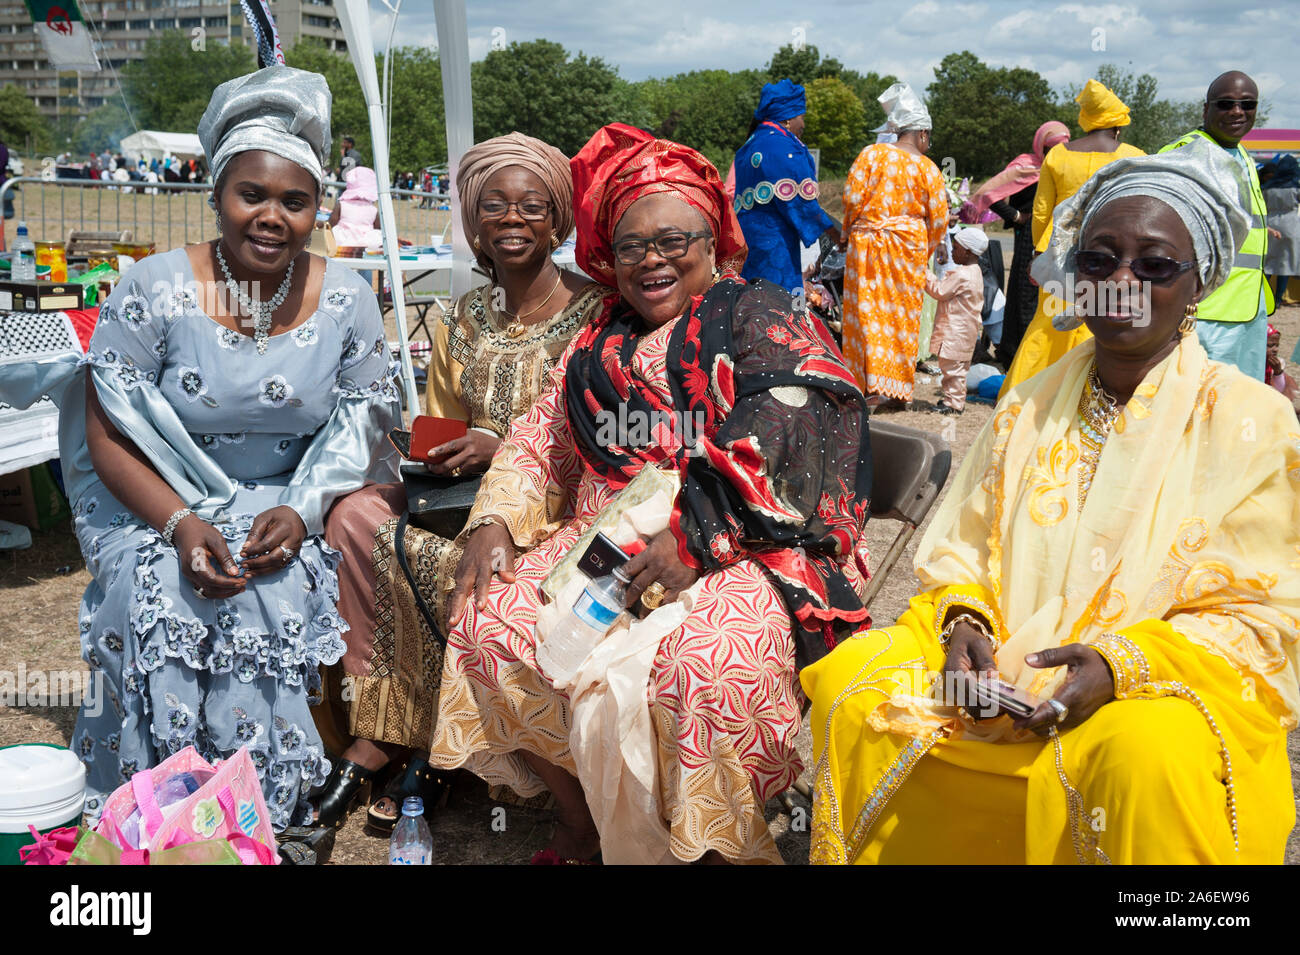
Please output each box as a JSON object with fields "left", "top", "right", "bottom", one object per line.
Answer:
{"left": 61, "top": 249, "right": 399, "bottom": 829}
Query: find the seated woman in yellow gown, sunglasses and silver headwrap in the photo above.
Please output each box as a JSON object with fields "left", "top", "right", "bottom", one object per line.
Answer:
{"left": 802, "top": 140, "right": 1300, "bottom": 863}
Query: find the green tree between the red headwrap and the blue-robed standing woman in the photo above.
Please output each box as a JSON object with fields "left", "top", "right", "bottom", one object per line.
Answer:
{"left": 636, "top": 70, "right": 767, "bottom": 175}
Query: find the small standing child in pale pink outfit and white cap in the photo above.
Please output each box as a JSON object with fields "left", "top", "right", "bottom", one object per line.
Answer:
{"left": 926, "top": 229, "right": 988, "bottom": 414}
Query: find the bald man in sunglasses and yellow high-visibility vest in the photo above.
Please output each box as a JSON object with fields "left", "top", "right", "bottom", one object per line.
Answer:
{"left": 1161, "top": 70, "right": 1274, "bottom": 381}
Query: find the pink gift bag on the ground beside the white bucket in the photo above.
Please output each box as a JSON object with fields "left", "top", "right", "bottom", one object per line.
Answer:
{"left": 95, "top": 746, "right": 280, "bottom": 865}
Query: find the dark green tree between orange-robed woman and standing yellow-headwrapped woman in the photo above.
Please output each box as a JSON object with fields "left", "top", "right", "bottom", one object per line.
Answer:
{"left": 926, "top": 51, "right": 1067, "bottom": 178}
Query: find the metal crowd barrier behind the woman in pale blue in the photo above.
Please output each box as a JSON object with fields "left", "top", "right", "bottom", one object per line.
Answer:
{"left": 0, "top": 175, "right": 451, "bottom": 252}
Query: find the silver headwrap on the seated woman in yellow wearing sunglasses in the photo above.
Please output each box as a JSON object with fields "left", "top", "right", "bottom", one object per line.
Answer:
{"left": 1030, "top": 136, "right": 1251, "bottom": 331}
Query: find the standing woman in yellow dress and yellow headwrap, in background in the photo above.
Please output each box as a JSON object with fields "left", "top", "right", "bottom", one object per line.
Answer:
{"left": 998, "top": 79, "right": 1145, "bottom": 398}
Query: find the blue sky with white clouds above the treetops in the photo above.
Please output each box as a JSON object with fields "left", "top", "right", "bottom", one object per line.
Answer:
{"left": 371, "top": 0, "right": 1300, "bottom": 129}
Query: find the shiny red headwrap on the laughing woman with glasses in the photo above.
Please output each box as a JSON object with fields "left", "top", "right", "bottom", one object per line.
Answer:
{"left": 569, "top": 122, "right": 749, "bottom": 287}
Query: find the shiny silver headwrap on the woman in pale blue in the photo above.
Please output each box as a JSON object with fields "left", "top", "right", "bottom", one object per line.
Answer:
{"left": 199, "top": 65, "right": 332, "bottom": 203}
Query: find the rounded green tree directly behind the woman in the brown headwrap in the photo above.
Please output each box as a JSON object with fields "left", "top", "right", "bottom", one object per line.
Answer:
{"left": 471, "top": 40, "right": 645, "bottom": 155}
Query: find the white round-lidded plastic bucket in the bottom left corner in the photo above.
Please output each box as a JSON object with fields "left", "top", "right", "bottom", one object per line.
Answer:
{"left": 0, "top": 743, "right": 86, "bottom": 865}
